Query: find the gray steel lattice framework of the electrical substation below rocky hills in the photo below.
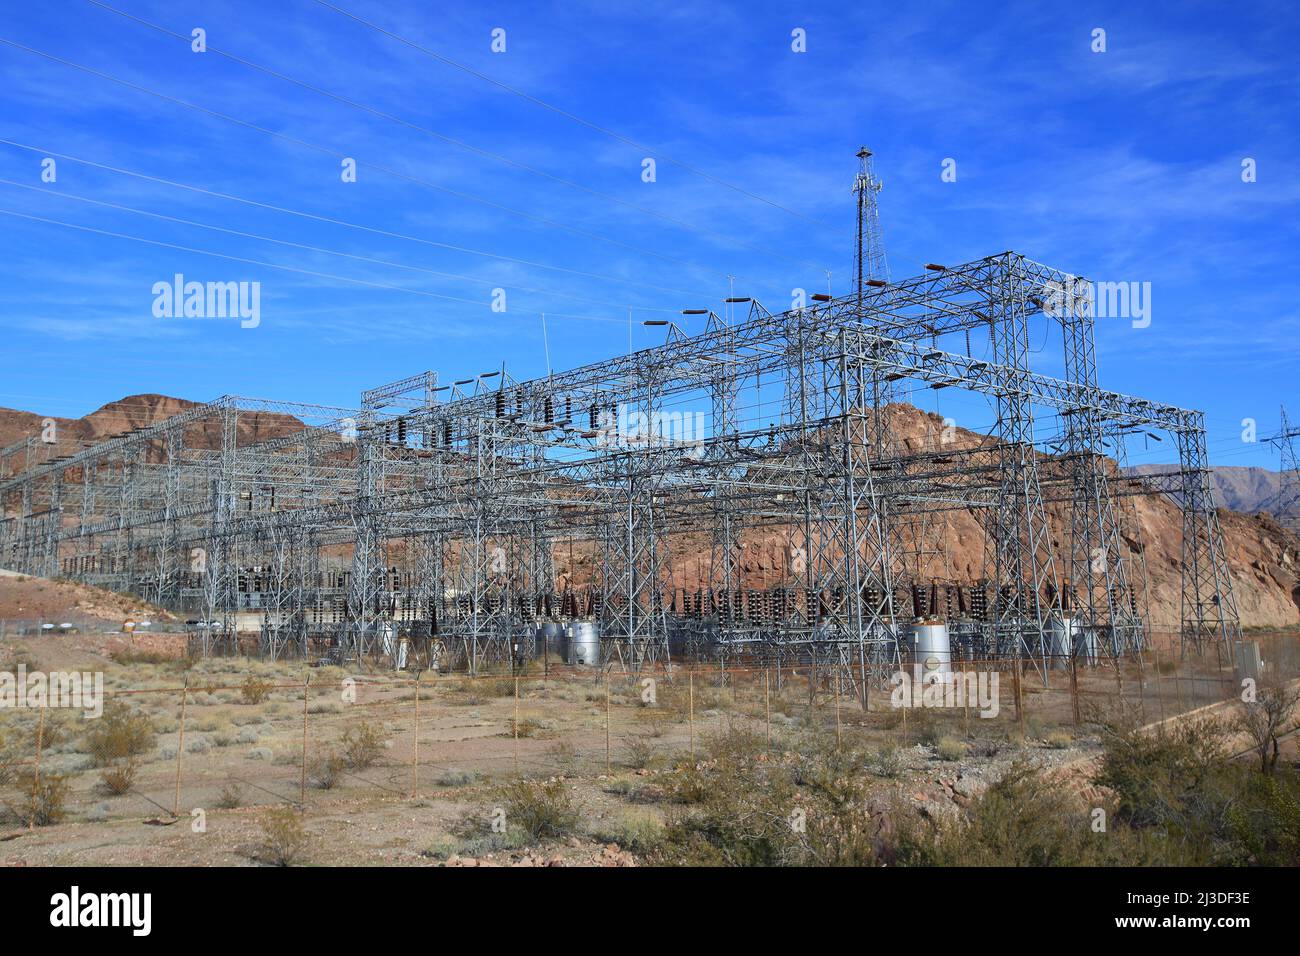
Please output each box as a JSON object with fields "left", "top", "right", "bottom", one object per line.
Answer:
{"left": 0, "top": 217, "right": 1240, "bottom": 695}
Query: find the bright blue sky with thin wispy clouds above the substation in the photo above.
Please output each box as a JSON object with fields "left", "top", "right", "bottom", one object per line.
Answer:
{"left": 0, "top": 0, "right": 1300, "bottom": 467}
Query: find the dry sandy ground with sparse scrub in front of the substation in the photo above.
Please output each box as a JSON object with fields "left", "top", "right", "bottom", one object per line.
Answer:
{"left": 0, "top": 579, "right": 1295, "bottom": 866}
